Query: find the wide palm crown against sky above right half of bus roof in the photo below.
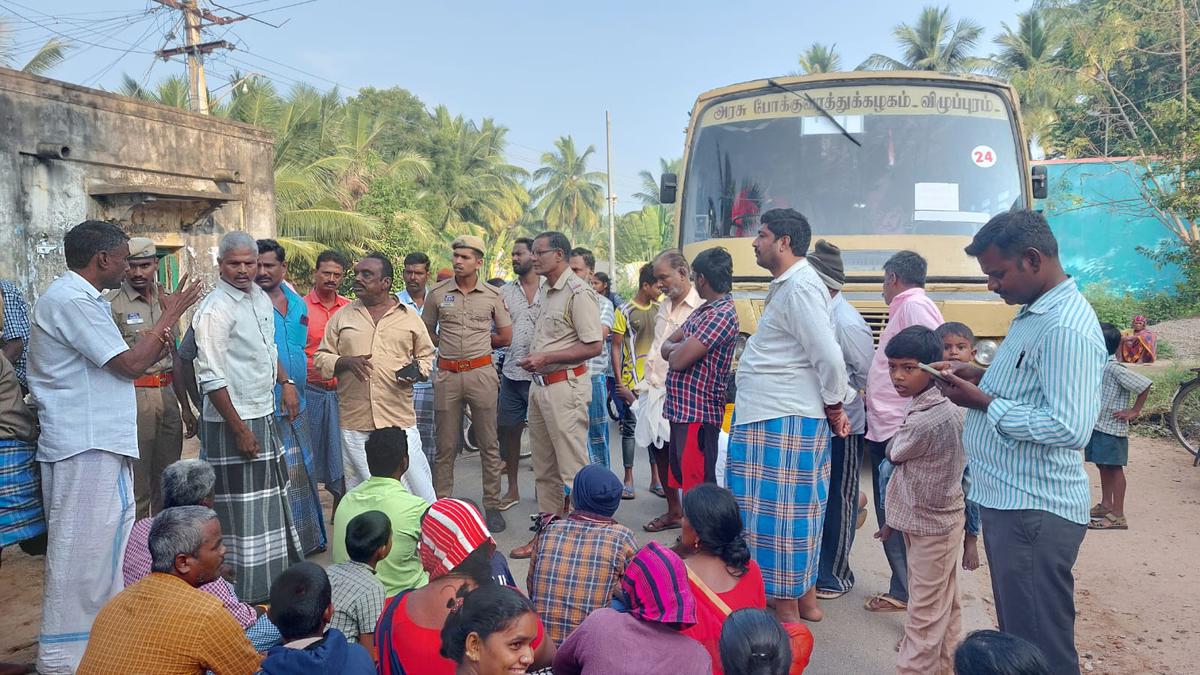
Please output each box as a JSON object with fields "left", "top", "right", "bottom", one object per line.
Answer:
{"left": 858, "top": 6, "right": 988, "bottom": 73}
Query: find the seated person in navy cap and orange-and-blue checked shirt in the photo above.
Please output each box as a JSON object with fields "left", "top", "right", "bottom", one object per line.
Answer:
{"left": 526, "top": 464, "right": 637, "bottom": 644}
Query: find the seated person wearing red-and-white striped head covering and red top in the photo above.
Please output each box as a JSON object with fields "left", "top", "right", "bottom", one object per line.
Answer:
{"left": 376, "top": 500, "right": 554, "bottom": 675}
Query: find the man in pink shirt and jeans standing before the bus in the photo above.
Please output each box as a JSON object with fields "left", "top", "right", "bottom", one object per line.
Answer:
{"left": 866, "top": 251, "right": 944, "bottom": 611}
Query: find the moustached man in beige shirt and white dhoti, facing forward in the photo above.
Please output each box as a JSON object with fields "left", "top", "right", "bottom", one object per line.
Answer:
{"left": 312, "top": 253, "right": 436, "bottom": 502}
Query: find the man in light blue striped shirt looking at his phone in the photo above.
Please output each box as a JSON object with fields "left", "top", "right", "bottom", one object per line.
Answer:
{"left": 937, "top": 210, "right": 1108, "bottom": 673}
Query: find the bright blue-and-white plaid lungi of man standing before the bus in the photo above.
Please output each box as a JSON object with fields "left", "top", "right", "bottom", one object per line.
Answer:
{"left": 727, "top": 416, "right": 829, "bottom": 599}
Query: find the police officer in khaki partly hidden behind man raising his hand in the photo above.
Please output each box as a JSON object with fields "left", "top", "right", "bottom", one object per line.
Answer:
{"left": 108, "top": 237, "right": 196, "bottom": 518}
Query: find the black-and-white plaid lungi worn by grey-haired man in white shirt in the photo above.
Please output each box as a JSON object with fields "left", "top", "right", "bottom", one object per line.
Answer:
{"left": 203, "top": 416, "right": 304, "bottom": 604}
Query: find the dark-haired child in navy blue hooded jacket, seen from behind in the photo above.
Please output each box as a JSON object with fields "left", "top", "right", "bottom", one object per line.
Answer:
{"left": 262, "top": 562, "right": 376, "bottom": 675}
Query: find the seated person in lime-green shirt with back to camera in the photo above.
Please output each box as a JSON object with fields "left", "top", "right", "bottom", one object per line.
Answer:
{"left": 332, "top": 426, "right": 430, "bottom": 597}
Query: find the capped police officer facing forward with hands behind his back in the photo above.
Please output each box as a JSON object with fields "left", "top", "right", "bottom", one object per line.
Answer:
{"left": 421, "top": 234, "right": 512, "bottom": 532}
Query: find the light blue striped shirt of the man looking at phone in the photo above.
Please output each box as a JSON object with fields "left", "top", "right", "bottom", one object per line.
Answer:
{"left": 962, "top": 279, "right": 1108, "bottom": 525}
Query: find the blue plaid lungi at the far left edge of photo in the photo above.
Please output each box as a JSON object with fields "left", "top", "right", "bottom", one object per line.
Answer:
{"left": 0, "top": 440, "right": 46, "bottom": 546}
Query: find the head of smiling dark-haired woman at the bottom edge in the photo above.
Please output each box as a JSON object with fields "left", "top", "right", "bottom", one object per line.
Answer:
{"left": 442, "top": 585, "right": 540, "bottom": 675}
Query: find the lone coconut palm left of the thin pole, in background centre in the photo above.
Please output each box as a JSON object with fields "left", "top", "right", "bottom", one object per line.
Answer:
{"left": 530, "top": 136, "right": 605, "bottom": 241}
